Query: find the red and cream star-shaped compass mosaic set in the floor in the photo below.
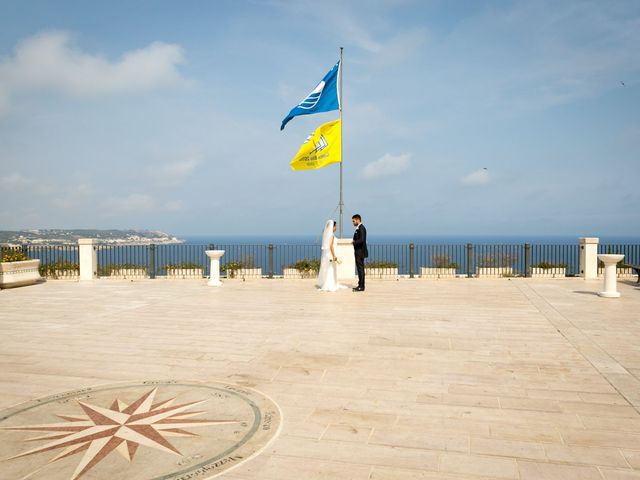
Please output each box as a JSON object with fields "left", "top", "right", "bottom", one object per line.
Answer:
{"left": 3, "top": 388, "right": 242, "bottom": 480}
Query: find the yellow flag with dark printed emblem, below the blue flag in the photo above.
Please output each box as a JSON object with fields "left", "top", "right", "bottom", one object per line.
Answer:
{"left": 291, "top": 120, "right": 342, "bottom": 170}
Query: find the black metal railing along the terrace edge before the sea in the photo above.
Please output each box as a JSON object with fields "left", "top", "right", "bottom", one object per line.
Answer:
{"left": 1, "top": 243, "right": 640, "bottom": 278}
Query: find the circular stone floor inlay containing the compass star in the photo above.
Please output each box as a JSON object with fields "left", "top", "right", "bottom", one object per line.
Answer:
{"left": 0, "top": 381, "right": 282, "bottom": 480}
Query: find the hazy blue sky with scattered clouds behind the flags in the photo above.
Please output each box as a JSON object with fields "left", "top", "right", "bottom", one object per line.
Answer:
{"left": 0, "top": 0, "right": 640, "bottom": 236}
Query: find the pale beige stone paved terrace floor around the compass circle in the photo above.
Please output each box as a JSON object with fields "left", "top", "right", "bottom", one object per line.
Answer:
{"left": 0, "top": 278, "right": 640, "bottom": 480}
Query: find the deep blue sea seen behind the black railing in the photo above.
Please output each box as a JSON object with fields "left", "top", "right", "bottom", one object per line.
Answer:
{"left": 169, "top": 234, "right": 640, "bottom": 275}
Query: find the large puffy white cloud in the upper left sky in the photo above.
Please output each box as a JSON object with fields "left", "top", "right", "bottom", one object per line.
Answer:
{"left": 0, "top": 31, "right": 187, "bottom": 109}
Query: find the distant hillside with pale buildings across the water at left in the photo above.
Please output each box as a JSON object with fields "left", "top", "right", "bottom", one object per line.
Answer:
{"left": 0, "top": 230, "right": 183, "bottom": 245}
